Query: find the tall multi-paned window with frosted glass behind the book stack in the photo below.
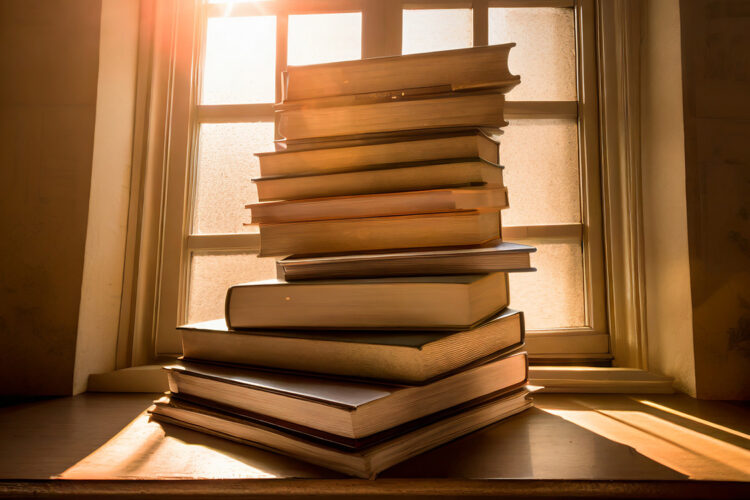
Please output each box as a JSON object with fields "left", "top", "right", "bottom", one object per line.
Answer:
{"left": 140, "top": 0, "right": 609, "bottom": 360}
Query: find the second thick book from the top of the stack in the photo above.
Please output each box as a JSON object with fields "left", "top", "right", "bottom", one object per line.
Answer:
{"left": 276, "top": 91, "right": 507, "bottom": 140}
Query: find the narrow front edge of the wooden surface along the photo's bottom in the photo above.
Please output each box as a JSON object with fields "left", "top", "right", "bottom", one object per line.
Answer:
{"left": 0, "top": 479, "right": 749, "bottom": 500}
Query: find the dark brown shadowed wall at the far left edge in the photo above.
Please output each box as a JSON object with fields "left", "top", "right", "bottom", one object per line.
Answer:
{"left": 0, "top": 0, "right": 101, "bottom": 394}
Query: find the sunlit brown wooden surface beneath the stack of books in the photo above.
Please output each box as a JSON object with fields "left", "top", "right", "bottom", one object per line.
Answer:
{"left": 0, "top": 394, "right": 750, "bottom": 498}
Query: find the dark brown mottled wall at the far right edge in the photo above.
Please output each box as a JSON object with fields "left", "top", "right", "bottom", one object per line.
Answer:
{"left": 680, "top": 0, "right": 750, "bottom": 399}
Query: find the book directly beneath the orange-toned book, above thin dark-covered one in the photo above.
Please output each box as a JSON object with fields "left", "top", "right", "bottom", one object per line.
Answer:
{"left": 258, "top": 209, "right": 500, "bottom": 257}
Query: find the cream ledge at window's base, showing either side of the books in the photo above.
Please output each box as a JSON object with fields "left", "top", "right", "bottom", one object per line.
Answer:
{"left": 88, "top": 364, "right": 674, "bottom": 394}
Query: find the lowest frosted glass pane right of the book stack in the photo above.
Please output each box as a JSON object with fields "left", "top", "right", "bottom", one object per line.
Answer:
{"left": 510, "top": 241, "right": 584, "bottom": 330}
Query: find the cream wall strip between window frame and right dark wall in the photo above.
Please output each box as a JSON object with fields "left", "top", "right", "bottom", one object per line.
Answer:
{"left": 641, "top": 0, "right": 696, "bottom": 396}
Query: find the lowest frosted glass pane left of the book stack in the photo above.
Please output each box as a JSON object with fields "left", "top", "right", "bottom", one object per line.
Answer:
{"left": 187, "top": 252, "right": 276, "bottom": 323}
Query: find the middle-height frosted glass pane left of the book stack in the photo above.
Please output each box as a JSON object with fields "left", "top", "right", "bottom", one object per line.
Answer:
{"left": 193, "top": 122, "right": 273, "bottom": 234}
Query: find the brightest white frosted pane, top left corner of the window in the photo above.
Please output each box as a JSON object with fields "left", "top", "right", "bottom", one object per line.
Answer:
{"left": 201, "top": 16, "right": 276, "bottom": 104}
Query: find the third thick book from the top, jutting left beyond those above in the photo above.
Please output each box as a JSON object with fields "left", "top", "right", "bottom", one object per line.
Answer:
{"left": 255, "top": 130, "right": 500, "bottom": 177}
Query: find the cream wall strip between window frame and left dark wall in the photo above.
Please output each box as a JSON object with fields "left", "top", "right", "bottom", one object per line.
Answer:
{"left": 74, "top": 0, "right": 140, "bottom": 393}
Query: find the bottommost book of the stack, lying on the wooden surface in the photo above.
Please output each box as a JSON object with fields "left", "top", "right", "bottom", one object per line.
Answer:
{"left": 149, "top": 389, "right": 532, "bottom": 478}
